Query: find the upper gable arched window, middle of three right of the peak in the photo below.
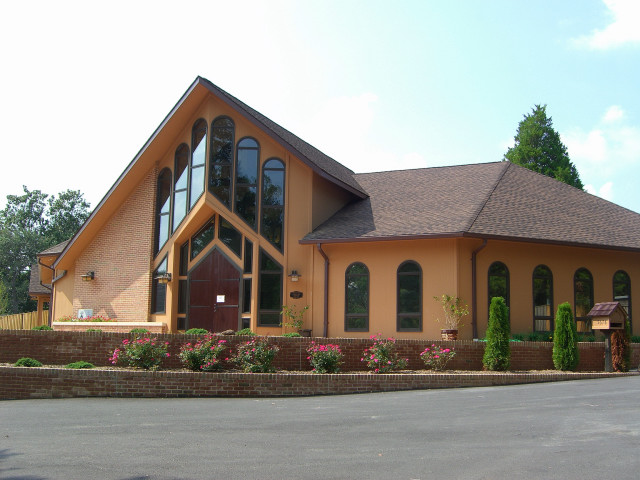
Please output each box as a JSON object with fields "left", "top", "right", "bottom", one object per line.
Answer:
{"left": 235, "top": 138, "right": 260, "bottom": 230}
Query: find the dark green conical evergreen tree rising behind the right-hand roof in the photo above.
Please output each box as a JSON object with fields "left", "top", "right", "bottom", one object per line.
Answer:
{"left": 504, "top": 105, "right": 583, "bottom": 190}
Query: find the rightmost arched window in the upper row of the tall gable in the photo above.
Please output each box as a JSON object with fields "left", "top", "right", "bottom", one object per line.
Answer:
{"left": 260, "top": 158, "right": 284, "bottom": 251}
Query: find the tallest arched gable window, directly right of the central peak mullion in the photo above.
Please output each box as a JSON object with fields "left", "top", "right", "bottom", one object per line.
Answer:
{"left": 209, "top": 117, "right": 235, "bottom": 208}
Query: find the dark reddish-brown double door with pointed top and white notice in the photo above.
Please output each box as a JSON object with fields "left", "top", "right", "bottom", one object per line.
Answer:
{"left": 188, "top": 249, "right": 242, "bottom": 332}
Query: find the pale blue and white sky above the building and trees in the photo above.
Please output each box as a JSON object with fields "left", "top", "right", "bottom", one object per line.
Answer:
{"left": 0, "top": 0, "right": 640, "bottom": 212}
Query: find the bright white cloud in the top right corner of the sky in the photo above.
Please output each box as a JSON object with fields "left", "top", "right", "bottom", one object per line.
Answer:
{"left": 574, "top": 0, "right": 640, "bottom": 50}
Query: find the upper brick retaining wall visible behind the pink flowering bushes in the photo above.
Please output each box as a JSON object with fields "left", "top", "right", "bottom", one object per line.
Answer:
{"left": 0, "top": 332, "right": 640, "bottom": 372}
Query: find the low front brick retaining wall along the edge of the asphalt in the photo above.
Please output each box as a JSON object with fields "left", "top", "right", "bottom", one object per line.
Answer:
{"left": 0, "top": 367, "right": 638, "bottom": 400}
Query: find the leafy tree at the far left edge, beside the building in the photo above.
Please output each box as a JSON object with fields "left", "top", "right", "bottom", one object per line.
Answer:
{"left": 0, "top": 186, "right": 89, "bottom": 313}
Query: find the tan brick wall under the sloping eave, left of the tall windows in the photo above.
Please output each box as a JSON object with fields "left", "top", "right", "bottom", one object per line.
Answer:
{"left": 71, "top": 168, "right": 157, "bottom": 321}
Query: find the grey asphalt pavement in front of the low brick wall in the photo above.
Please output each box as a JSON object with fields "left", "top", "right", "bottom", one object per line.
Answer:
{"left": 0, "top": 377, "right": 640, "bottom": 480}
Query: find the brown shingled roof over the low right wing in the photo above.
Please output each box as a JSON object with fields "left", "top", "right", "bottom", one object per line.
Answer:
{"left": 301, "top": 162, "right": 640, "bottom": 251}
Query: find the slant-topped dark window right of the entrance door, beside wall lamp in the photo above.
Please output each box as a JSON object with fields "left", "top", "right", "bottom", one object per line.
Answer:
{"left": 258, "top": 249, "right": 283, "bottom": 327}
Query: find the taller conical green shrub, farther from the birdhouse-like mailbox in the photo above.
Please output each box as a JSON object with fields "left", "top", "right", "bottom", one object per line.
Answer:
{"left": 482, "top": 297, "right": 511, "bottom": 371}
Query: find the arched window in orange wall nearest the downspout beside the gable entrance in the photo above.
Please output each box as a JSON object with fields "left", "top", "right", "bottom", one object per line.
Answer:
{"left": 344, "top": 262, "right": 369, "bottom": 332}
